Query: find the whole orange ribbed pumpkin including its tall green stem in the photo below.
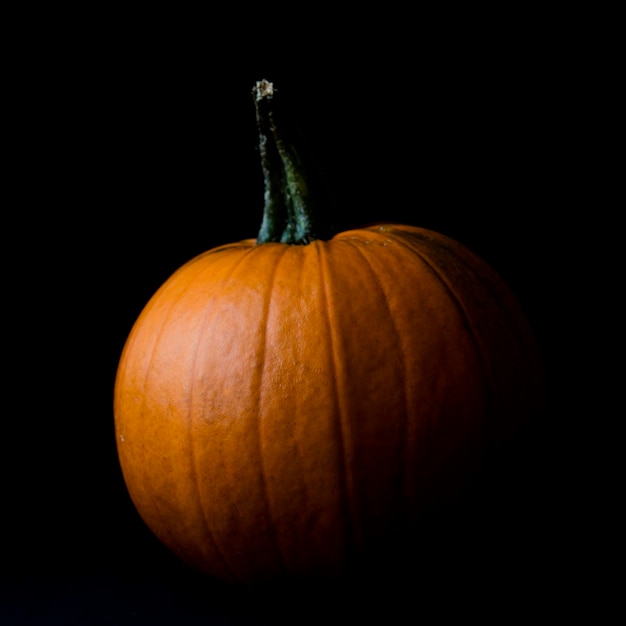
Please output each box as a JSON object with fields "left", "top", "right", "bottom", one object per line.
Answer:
{"left": 114, "top": 81, "right": 542, "bottom": 583}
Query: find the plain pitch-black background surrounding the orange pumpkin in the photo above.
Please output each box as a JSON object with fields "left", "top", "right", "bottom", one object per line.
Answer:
{"left": 0, "top": 14, "right": 612, "bottom": 624}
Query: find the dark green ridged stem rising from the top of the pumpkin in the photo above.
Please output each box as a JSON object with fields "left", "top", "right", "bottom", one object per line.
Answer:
{"left": 252, "top": 80, "right": 319, "bottom": 245}
